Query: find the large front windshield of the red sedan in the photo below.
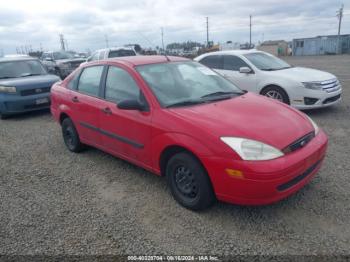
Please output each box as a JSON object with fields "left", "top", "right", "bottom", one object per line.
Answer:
{"left": 136, "top": 62, "right": 243, "bottom": 107}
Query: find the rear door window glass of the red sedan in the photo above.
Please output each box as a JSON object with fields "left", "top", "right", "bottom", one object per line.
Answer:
{"left": 78, "top": 66, "right": 103, "bottom": 96}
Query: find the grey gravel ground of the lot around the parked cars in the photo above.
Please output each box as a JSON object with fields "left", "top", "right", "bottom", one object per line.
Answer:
{"left": 0, "top": 56, "right": 350, "bottom": 255}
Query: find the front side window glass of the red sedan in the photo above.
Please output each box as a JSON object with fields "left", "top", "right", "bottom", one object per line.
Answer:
{"left": 105, "top": 66, "right": 140, "bottom": 103}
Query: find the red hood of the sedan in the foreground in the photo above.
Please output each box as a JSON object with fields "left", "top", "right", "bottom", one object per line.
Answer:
{"left": 170, "top": 93, "right": 313, "bottom": 149}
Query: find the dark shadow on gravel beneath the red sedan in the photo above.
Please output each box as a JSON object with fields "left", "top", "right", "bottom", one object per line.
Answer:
{"left": 86, "top": 145, "right": 314, "bottom": 223}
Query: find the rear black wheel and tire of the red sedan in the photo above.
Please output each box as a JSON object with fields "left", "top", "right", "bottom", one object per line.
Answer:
{"left": 62, "top": 118, "right": 84, "bottom": 153}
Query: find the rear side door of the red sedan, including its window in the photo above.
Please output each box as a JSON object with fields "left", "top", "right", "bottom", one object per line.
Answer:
{"left": 70, "top": 65, "right": 104, "bottom": 145}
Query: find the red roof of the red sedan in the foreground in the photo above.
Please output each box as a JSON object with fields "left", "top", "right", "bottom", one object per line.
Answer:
{"left": 88, "top": 55, "right": 191, "bottom": 66}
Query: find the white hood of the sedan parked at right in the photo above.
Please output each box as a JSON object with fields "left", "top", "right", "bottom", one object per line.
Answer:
{"left": 266, "top": 67, "right": 336, "bottom": 82}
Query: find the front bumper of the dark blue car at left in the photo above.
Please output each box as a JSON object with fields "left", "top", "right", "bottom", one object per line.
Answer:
{"left": 0, "top": 93, "right": 50, "bottom": 115}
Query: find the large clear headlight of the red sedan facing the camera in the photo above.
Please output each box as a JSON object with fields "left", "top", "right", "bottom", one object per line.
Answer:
{"left": 220, "top": 137, "right": 284, "bottom": 160}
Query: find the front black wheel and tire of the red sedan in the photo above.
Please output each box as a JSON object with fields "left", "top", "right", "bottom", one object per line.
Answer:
{"left": 166, "top": 152, "right": 216, "bottom": 210}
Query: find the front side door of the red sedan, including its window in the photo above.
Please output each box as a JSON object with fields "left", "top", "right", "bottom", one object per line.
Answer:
{"left": 99, "top": 66, "right": 152, "bottom": 166}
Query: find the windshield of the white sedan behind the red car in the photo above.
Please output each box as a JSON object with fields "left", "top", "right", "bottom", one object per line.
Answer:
{"left": 244, "top": 53, "right": 291, "bottom": 71}
